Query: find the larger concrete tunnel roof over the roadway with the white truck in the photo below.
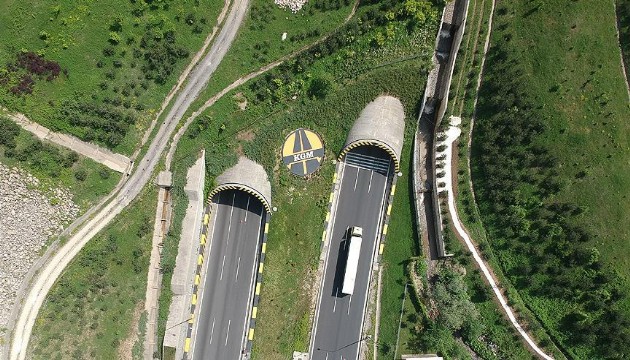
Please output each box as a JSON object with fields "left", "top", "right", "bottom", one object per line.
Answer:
{"left": 339, "top": 95, "right": 405, "bottom": 172}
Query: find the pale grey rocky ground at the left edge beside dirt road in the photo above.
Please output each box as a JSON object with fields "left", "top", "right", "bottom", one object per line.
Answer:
{"left": 0, "top": 164, "right": 79, "bottom": 347}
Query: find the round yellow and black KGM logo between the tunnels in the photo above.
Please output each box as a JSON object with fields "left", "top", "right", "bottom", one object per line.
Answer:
{"left": 282, "top": 128, "right": 324, "bottom": 176}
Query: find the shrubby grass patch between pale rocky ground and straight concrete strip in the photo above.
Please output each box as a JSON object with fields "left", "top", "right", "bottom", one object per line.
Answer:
{"left": 0, "top": 115, "right": 120, "bottom": 212}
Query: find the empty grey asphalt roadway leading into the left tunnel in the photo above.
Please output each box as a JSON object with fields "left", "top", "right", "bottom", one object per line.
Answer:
{"left": 192, "top": 190, "right": 264, "bottom": 360}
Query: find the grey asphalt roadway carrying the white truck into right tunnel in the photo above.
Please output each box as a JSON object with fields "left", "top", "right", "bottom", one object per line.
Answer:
{"left": 311, "top": 147, "right": 393, "bottom": 360}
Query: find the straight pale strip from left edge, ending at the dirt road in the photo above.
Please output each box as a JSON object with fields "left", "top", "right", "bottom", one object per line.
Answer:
{"left": 0, "top": 107, "right": 131, "bottom": 173}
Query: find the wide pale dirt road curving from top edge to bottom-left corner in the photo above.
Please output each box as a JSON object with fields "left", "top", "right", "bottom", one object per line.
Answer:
{"left": 9, "top": 0, "right": 249, "bottom": 360}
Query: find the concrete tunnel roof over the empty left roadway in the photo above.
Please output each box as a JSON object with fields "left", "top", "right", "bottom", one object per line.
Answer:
{"left": 209, "top": 156, "right": 271, "bottom": 213}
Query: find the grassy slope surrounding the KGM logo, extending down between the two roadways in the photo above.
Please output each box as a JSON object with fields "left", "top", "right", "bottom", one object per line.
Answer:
{"left": 155, "top": 0, "right": 442, "bottom": 360}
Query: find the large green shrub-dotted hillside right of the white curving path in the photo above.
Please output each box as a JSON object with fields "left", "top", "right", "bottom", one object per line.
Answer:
{"left": 464, "top": 1, "right": 630, "bottom": 358}
